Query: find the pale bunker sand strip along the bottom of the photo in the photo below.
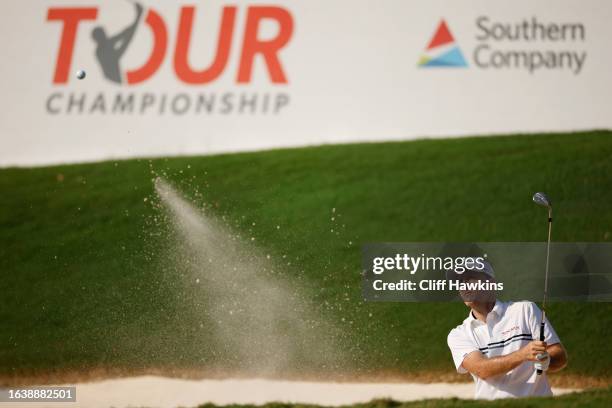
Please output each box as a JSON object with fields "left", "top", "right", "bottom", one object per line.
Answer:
{"left": 0, "top": 376, "right": 574, "bottom": 408}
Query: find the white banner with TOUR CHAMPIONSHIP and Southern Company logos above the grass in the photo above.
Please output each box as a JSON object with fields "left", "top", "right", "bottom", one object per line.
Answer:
{"left": 0, "top": 0, "right": 612, "bottom": 166}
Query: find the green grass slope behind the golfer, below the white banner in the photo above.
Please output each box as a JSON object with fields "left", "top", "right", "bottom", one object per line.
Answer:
{"left": 0, "top": 131, "right": 612, "bottom": 378}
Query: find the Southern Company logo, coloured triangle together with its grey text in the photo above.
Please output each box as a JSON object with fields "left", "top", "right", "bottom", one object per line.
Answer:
{"left": 418, "top": 16, "right": 587, "bottom": 75}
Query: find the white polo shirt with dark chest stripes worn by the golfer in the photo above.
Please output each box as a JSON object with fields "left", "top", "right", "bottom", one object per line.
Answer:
{"left": 447, "top": 300, "right": 560, "bottom": 399}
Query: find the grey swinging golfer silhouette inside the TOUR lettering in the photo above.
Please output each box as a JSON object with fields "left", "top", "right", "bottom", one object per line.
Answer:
{"left": 91, "top": 2, "right": 143, "bottom": 84}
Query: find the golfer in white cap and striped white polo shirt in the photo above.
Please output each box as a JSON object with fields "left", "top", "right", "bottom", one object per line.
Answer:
{"left": 447, "top": 262, "right": 567, "bottom": 399}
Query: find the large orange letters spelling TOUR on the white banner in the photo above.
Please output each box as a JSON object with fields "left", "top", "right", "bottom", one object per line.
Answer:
{"left": 47, "top": 3, "right": 293, "bottom": 85}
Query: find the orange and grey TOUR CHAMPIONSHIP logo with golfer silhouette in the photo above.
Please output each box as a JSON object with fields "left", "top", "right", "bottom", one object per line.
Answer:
{"left": 46, "top": 2, "right": 293, "bottom": 115}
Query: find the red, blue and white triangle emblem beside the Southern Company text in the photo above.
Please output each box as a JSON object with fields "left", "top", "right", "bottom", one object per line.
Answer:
{"left": 419, "top": 20, "right": 467, "bottom": 67}
